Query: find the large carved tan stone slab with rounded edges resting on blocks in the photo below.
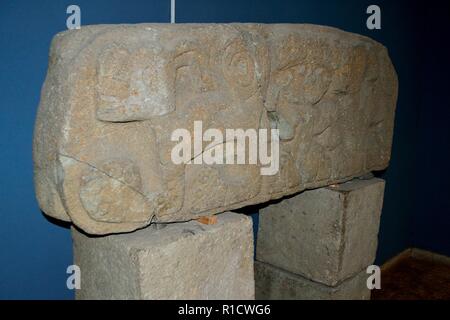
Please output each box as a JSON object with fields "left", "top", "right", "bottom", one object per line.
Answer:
{"left": 33, "top": 24, "right": 397, "bottom": 234}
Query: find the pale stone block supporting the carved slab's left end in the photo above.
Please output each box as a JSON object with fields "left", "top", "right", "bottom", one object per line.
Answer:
{"left": 72, "top": 213, "right": 254, "bottom": 299}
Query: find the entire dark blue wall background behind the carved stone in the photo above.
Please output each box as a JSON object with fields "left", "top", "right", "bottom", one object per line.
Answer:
{"left": 0, "top": 0, "right": 450, "bottom": 299}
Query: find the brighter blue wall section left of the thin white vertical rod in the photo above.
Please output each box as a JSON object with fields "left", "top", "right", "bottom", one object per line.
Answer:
{"left": 0, "top": 0, "right": 170, "bottom": 299}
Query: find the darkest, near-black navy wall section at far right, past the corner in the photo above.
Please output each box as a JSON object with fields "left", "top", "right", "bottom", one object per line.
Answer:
{"left": 411, "top": 5, "right": 450, "bottom": 256}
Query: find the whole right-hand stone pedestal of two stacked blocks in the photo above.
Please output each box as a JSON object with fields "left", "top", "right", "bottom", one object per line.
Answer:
{"left": 255, "top": 178, "right": 384, "bottom": 299}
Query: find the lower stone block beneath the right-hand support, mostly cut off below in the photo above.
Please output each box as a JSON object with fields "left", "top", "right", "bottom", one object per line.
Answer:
{"left": 255, "top": 261, "right": 370, "bottom": 300}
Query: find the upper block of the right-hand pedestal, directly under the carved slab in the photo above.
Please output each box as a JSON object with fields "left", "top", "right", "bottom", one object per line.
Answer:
{"left": 256, "top": 178, "right": 385, "bottom": 286}
